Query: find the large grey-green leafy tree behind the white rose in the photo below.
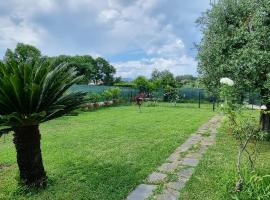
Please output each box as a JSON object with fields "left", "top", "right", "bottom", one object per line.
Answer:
{"left": 197, "top": 0, "right": 270, "bottom": 134}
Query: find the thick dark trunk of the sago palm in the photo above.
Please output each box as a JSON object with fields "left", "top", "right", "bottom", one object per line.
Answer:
{"left": 13, "top": 125, "right": 47, "bottom": 187}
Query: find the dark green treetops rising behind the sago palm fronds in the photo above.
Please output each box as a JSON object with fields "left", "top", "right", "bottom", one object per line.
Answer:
{"left": 3, "top": 43, "right": 119, "bottom": 85}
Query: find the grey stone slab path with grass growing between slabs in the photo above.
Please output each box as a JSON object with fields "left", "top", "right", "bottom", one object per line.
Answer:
{"left": 127, "top": 115, "right": 223, "bottom": 200}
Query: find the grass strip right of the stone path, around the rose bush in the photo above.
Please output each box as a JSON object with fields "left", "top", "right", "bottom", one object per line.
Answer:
{"left": 181, "top": 111, "right": 270, "bottom": 200}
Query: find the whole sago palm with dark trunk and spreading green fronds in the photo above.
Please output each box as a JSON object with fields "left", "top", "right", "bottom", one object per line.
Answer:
{"left": 0, "top": 61, "right": 84, "bottom": 186}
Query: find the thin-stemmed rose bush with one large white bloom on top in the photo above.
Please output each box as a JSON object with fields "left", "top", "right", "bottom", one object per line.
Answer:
{"left": 220, "top": 78, "right": 265, "bottom": 192}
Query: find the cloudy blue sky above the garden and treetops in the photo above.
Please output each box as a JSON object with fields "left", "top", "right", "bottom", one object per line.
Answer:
{"left": 0, "top": 0, "right": 209, "bottom": 78}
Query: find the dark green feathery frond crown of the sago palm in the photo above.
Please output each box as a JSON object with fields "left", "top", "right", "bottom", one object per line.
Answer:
{"left": 0, "top": 61, "right": 85, "bottom": 128}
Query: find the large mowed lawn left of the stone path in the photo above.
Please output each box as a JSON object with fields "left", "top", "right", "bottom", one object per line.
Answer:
{"left": 0, "top": 104, "right": 215, "bottom": 200}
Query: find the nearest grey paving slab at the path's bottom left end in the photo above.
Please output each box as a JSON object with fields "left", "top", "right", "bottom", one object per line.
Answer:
{"left": 127, "top": 184, "right": 157, "bottom": 200}
